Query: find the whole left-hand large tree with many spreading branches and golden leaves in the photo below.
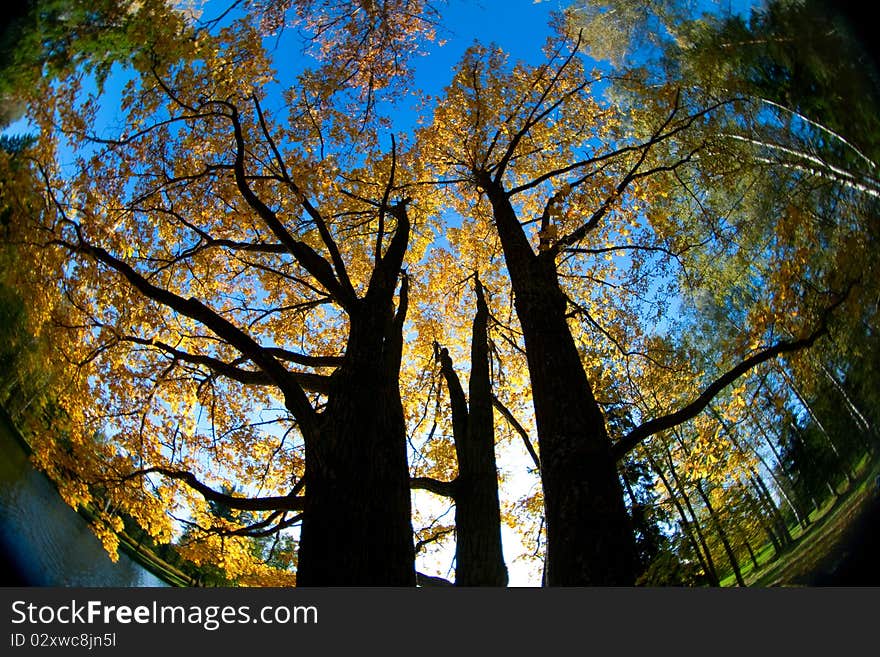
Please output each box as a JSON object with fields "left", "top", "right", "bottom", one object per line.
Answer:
{"left": 1, "top": 0, "right": 446, "bottom": 585}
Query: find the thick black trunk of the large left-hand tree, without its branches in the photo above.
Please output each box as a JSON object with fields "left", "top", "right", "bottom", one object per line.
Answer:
{"left": 297, "top": 207, "right": 416, "bottom": 586}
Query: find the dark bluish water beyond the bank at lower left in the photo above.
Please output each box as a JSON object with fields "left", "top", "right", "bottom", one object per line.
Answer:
{"left": 0, "top": 412, "right": 168, "bottom": 587}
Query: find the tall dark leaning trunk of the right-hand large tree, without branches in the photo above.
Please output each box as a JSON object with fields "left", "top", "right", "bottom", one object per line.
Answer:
{"left": 480, "top": 175, "right": 635, "bottom": 586}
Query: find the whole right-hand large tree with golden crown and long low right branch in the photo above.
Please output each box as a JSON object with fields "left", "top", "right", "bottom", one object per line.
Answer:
{"left": 422, "top": 15, "right": 868, "bottom": 584}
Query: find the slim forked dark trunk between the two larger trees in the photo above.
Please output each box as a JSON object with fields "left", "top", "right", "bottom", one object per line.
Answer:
{"left": 435, "top": 278, "right": 507, "bottom": 586}
